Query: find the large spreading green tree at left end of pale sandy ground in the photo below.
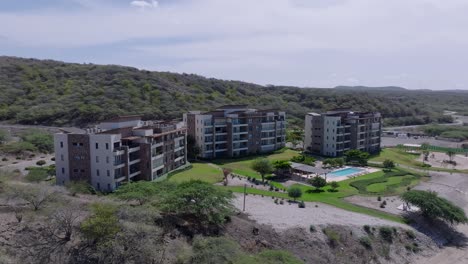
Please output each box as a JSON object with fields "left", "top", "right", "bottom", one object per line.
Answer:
{"left": 158, "top": 181, "right": 233, "bottom": 225}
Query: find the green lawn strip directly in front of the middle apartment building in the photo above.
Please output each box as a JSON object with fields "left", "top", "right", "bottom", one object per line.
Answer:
{"left": 213, "top": 149, "right": 300, "bottom": 179}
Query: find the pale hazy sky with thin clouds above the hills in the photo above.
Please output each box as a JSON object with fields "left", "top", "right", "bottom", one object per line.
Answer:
{"left": 0, "top": 0, "right": 468, "bottom": 90}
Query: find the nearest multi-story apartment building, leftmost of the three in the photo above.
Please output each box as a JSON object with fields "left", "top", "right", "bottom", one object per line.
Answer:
{"left": 54, "top": 116, "right": 187, "bottom": 192}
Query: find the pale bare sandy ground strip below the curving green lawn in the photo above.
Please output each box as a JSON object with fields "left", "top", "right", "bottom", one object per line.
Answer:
{"left": 233, "top": 195, "right": 408, "bottom": 231}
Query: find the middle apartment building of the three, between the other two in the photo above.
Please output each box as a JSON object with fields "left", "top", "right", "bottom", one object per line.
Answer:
{"left": 184, "top": 105, "right": 286, "bottom": 159}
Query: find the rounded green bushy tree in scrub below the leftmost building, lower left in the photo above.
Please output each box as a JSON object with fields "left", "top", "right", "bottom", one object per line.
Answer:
{"left": 80, "top": 203, "right": 120, "bottom": 242}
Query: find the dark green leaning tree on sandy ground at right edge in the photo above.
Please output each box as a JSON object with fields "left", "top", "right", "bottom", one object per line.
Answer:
{"left": 401, "top": 190, "right": 468, "bottom": 224}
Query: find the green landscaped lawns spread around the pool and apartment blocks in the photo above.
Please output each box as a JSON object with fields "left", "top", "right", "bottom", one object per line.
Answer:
{"left": 169, "top": 149, "right": 428, "bottom": 222}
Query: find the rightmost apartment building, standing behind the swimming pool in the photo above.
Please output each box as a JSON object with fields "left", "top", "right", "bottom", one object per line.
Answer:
{"left": 304, "top": 110, "right": 382, "bottom": 157}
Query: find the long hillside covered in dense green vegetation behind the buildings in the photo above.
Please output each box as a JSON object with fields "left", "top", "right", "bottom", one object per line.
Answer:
{"left": 0, "top": 57, "right": 468, "bottom": 126}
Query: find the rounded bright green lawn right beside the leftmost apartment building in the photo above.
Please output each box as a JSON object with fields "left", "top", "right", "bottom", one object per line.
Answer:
{"left": 169, "top": 163, "right": 223, "bottom": 183}
